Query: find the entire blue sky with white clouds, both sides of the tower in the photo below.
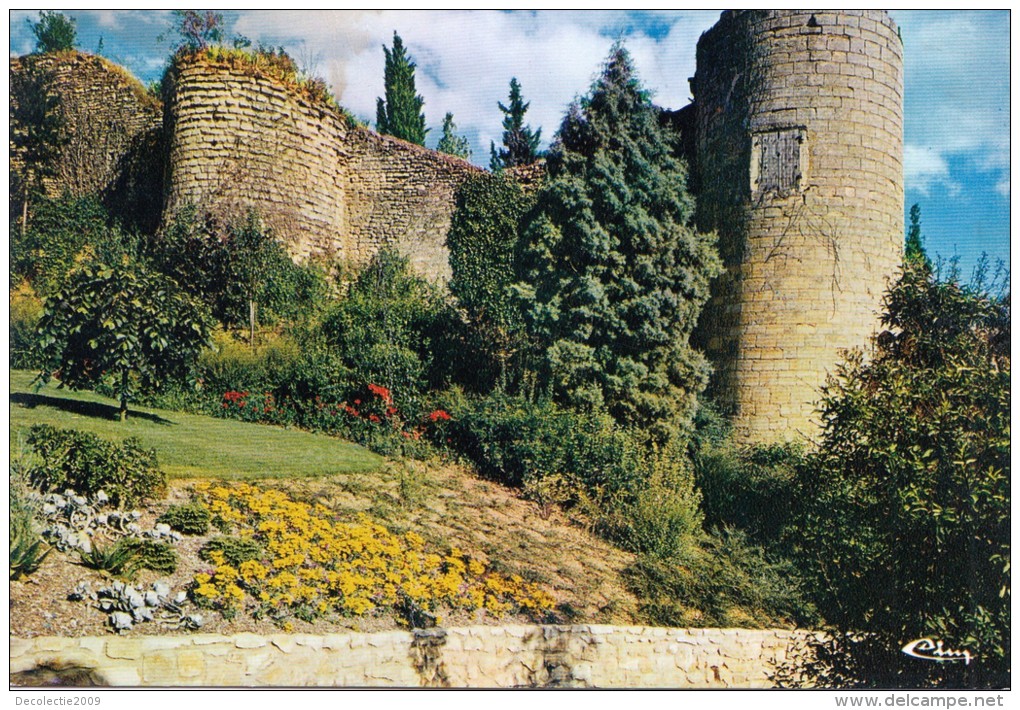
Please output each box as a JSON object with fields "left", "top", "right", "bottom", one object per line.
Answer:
{"left": 10, "top": 10, "right": 1011, "bottom": 273}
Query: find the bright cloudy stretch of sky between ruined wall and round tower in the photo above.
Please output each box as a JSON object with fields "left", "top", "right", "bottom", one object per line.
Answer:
{"left": 227, "top": 10, "right": 718, "bottom": 163}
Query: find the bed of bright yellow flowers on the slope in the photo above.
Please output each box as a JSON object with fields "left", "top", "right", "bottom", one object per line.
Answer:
{"left": 191, "top": 483, "right": 553, "bottom": 621}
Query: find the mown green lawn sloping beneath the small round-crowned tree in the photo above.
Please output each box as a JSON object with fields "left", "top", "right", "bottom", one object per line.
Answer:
{"left": 10, "top": 370, "right": 383, "bottom": 478}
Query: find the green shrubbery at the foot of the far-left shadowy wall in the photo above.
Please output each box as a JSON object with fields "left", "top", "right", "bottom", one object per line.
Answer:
{"left": 10, "top": 195, "right": 137, "bottom": 295}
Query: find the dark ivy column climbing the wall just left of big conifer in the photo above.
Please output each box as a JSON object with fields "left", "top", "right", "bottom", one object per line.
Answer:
{"left": 447, "top": 174, "right": 534, "bottom": 391}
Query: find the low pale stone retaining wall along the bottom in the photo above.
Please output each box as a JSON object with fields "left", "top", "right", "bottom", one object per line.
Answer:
{"left": 10, "top": 625, "right": 811, "bottom": 689}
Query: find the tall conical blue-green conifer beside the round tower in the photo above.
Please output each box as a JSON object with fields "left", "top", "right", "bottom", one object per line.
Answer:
{"left": 517, "top": 46, "right": 720, "bottom": 441}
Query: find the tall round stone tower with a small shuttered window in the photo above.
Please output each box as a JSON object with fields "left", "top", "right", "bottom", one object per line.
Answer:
{"left": 692, "top": 10, "right": 904, "bottom": 442}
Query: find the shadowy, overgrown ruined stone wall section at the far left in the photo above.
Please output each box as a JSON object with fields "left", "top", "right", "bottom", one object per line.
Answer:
{"left": 9, "top": 51, "right": 162, "bottom": 227}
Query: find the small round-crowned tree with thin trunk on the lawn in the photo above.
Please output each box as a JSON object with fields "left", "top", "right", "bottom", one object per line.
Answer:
{"left": 39, "top": 258, "right": 209, "bottom": 421}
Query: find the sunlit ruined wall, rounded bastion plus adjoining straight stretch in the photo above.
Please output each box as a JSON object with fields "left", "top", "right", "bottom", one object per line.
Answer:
{"left": 165, "top": 59, "right": 478, "bottom": 280}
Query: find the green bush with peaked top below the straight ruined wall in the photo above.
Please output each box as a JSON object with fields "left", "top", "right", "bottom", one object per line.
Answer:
{"left": 322, "top": 249, "right": 456, "bottom": 416}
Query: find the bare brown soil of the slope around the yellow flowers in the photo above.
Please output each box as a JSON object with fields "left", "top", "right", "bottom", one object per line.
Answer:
{"left": 10, "top": 461, "right": 638, "bottom": 638}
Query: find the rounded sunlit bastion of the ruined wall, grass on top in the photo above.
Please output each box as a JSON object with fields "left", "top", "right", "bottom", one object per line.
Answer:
{"left": 164, "top": 59, "right": 350, "bottom": 258}
